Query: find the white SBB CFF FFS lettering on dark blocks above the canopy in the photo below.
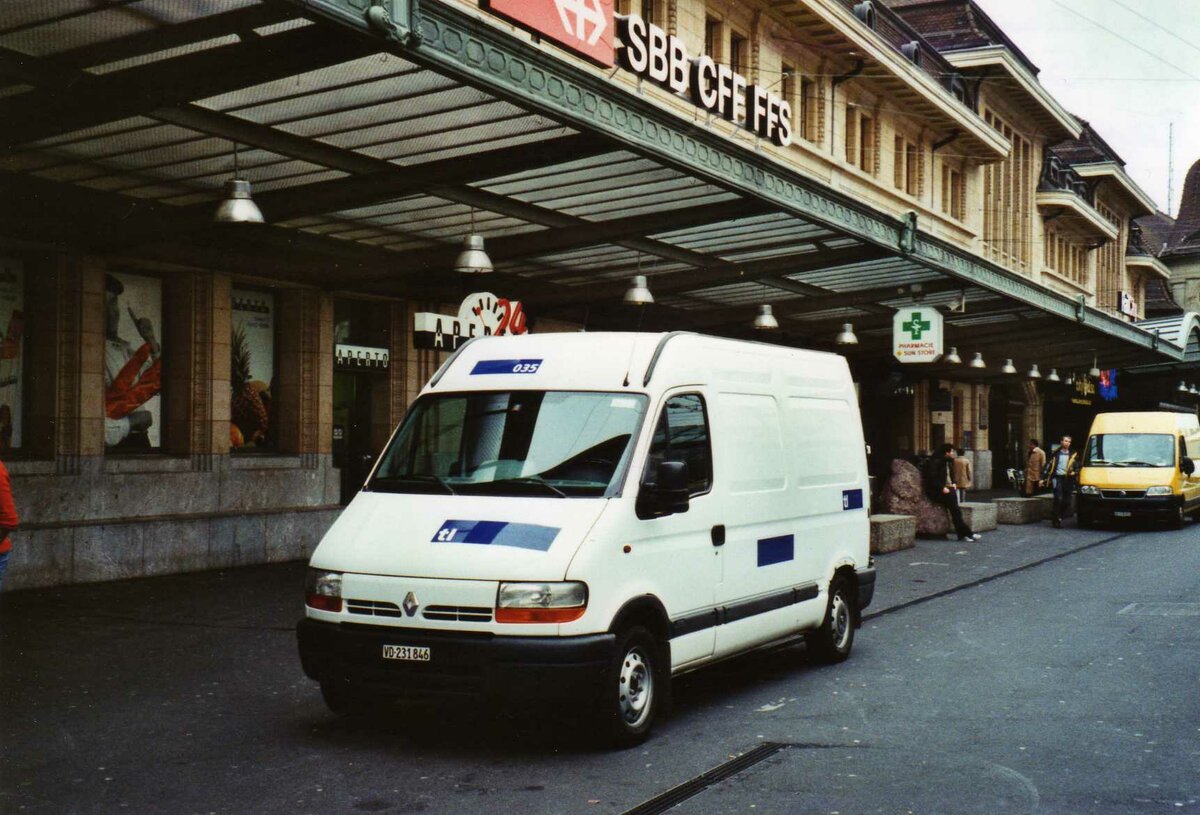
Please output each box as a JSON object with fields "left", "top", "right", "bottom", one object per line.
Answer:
{"left": 617, "top": 14, "right": 792, "bottom": 148}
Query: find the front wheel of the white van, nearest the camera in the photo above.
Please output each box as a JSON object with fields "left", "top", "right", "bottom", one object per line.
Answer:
{"left": 599, "top": 625, "right": 671, "bottom": 747}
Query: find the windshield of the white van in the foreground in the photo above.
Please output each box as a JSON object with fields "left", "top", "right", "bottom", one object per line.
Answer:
{"left": 366, "top": 390, "right": 647, "bottom": 498}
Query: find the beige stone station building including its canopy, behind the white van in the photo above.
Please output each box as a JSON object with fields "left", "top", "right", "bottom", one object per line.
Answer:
{"left": 0, "top": 0, "right": 1200, "bottom": 588}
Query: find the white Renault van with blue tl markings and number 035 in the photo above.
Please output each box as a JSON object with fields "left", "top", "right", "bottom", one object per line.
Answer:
{"left": 298, "top": 332, "right": 875, "bottom": 744}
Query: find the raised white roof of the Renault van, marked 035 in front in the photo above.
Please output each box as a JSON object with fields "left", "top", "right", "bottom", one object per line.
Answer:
{"left": 425, "top": 331, "right": 851, "bottom": 392}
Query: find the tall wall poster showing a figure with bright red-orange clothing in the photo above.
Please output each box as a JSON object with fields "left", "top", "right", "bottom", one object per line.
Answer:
{"left": 104, "top": 272, "right": 162, "bottom": 453}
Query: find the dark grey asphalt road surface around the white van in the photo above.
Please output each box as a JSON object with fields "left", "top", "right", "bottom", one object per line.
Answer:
{"left": 0, "top": 523, "right": 1200, "bottom": 815}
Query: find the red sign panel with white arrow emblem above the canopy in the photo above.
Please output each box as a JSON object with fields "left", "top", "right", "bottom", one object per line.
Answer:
{"left": 487, "top": 0, "right": 613, "bottom": 67}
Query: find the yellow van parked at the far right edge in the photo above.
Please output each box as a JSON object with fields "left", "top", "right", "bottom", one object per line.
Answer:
{"left": 1076, "top": 412, "right": 1200, "bottom": 527}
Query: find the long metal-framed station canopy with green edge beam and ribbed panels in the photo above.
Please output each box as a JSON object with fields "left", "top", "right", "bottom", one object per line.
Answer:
{"left": 0, "top": 0, "right": 1183, "bottom": 376}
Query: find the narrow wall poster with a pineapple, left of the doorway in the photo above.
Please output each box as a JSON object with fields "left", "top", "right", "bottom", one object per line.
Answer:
{"left": 229, "top": 289, "right": 275, "bottom": 450}
